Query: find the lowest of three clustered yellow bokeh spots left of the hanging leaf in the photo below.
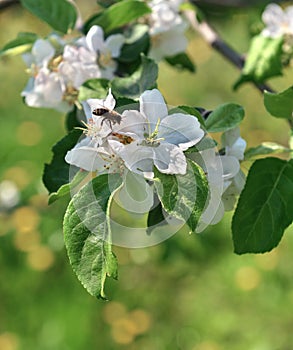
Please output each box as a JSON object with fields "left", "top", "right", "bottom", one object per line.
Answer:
{"left": 27, "top": 246, "right": 55, "bottom": 271}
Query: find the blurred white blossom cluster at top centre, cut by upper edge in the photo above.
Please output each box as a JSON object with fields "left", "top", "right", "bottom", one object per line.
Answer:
{"left": 148, "top": 0, "right": 188, "bottom": 61}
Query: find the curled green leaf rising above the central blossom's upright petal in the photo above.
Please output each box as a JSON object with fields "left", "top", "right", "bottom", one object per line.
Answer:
{"left": 112, "top": 56, "right": 158, "bottom": 98}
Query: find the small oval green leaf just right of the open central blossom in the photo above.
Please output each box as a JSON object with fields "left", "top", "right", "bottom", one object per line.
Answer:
{"left": 205, "top": 103, "right": 244, "bottom": 132}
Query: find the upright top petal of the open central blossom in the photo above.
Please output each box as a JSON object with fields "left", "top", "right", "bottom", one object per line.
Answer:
{"left": 139, "top": 89, "right": 168, "bottom": 127}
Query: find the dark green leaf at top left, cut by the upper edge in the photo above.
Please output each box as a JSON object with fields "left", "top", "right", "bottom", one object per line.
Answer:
{"left": 21, "top": 0, "right": 77, "bottom": 34}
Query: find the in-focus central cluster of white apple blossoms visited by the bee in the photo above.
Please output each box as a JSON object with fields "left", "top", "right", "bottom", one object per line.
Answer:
{"left": 65, "top": 89, "right": 246, "bottom": 231}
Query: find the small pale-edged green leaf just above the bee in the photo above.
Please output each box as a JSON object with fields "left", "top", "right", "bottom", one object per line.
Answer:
{"left": 78, "top": 79, "right": 109, "bottom": 101}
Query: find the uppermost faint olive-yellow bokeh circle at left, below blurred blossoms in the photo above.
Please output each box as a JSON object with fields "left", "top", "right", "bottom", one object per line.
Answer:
{"left": 16, "top": 121, "right": 43, "bottom": 146}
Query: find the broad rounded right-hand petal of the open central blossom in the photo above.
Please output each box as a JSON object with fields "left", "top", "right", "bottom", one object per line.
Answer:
{"left": 158, "top": 113, "right": 204, "bottom": 151}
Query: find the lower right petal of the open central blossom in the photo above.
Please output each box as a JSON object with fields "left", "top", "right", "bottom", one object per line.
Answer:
{"left": 153, "top": 143, "right": 187, "bottom": 175}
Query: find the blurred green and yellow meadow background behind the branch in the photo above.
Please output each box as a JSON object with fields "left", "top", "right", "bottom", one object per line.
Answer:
{"left": 0, "top": 1, "right": 293, "bottom": 350}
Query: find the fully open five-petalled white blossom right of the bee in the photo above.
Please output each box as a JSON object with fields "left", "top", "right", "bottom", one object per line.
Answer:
{"left": 108, "top": 89, "right": 204, "bottom": 178}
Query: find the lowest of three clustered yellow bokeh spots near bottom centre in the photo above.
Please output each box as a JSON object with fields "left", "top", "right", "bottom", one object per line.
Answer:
{"left": 111, "top": 317, "right": 136, "bottom": 344}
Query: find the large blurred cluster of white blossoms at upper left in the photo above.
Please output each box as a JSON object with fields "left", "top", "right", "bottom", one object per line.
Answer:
{"left": 22, "top": 26, "right": 124, "bottom": 112}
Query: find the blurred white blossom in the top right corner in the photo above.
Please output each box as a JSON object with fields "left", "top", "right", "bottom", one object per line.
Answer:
{"left": 262, "top": 4, "right": 293, "bottom": 38}
